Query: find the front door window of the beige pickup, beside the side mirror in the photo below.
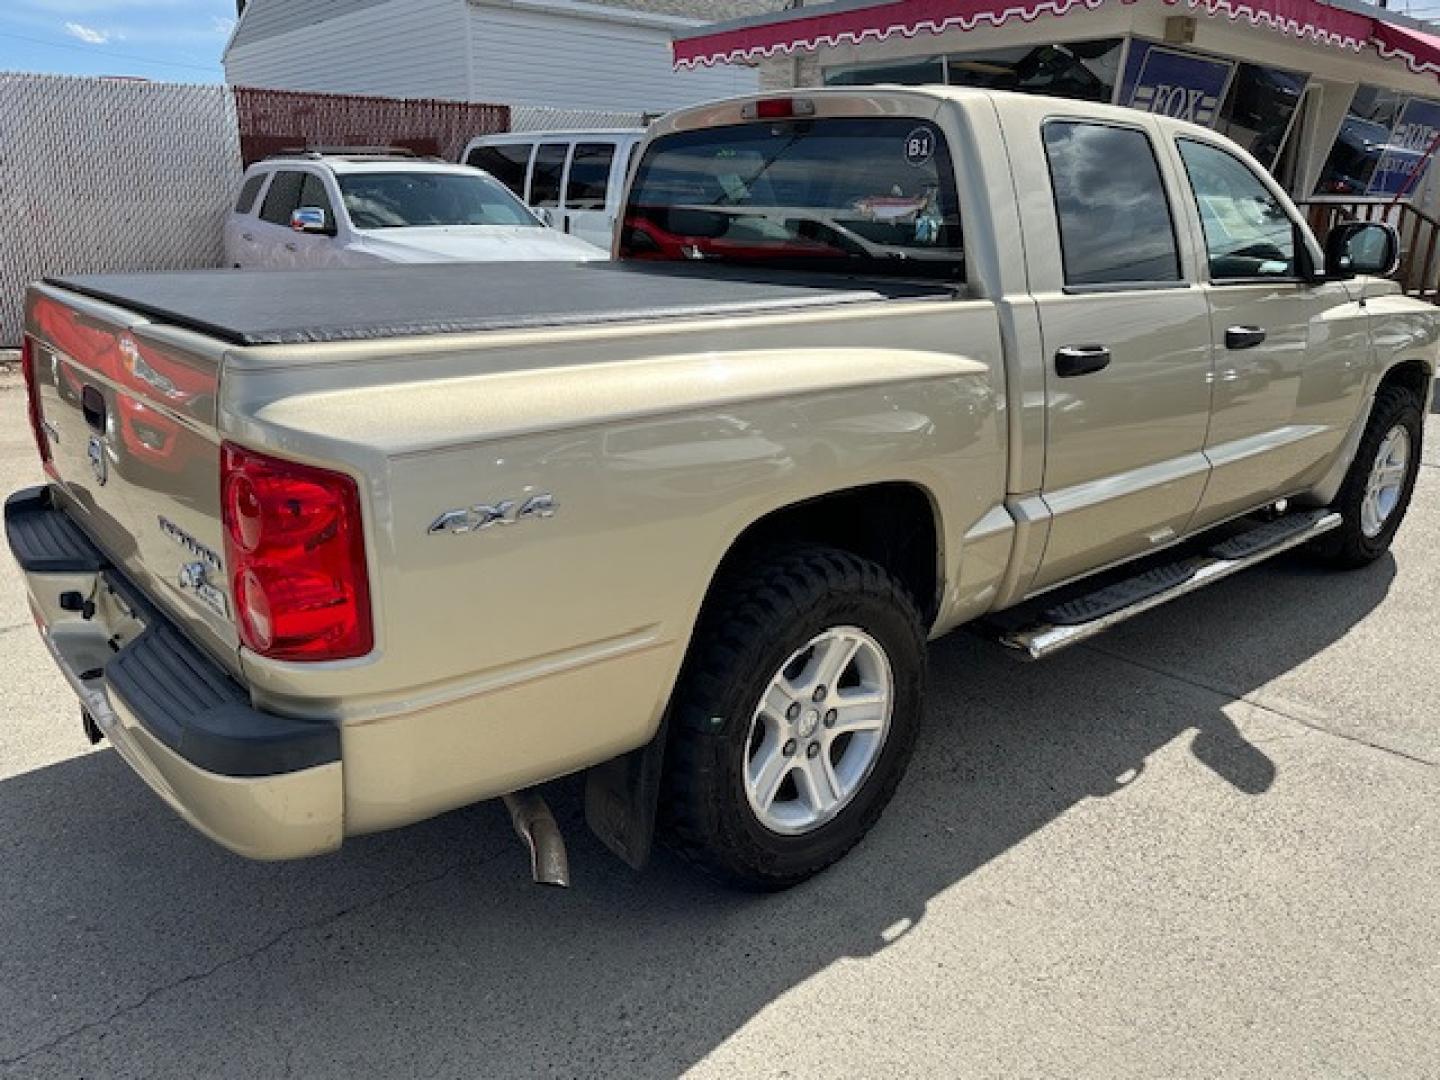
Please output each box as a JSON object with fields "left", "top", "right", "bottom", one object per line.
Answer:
{"left": 1179, "top": 138, "right": 1296, "bottom": 279}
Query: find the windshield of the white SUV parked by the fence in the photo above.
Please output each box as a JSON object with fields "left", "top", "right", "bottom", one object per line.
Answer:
{"left": 337, "top": 173, "right": 543, "bottom": 229}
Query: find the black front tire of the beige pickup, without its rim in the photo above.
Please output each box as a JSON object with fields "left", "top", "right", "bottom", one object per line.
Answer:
{"left": 1313, "top": 386, "right": 1424, "bottom": 570}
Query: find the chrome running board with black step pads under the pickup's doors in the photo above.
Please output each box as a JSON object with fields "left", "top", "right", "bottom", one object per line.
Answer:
{"left": 999, "top": 510, "right": 1342, "bottom": 660}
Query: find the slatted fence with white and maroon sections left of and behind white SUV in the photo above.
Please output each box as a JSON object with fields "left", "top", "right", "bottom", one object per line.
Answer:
{"left": 0, "top": 72, "right": 524, "bottom": 347}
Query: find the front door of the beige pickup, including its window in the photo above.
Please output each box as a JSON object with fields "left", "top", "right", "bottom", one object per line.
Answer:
{"left": 1175, "top": 135, "right": 1369, "bottom": 527}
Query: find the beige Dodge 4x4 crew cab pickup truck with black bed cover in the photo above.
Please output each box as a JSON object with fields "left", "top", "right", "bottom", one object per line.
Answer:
{"left": 6, "top": 88, "right": 1440, "bottom": 888}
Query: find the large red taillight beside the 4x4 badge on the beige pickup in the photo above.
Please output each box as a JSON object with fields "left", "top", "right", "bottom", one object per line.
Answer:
{"left": 220, "top": 442, "right": 374, "bottom": 661}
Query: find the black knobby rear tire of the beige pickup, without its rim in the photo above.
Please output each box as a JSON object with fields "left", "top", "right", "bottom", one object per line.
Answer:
{"left": 661, "top": 547, "right": 926, "bottom": 891}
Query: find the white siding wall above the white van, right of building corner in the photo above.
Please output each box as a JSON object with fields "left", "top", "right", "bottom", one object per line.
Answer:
{"left": 468, "top": 3, "right": 759, "bottom": 112}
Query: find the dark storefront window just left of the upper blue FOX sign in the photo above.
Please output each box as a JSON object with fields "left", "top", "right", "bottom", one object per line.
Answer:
{"left": 946, "top": 37, "right": 1120, "bottom": 101}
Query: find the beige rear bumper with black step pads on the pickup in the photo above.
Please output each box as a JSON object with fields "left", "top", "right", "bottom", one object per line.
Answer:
{"left": 4, "top": 488, "right": 344, "bottom": 858}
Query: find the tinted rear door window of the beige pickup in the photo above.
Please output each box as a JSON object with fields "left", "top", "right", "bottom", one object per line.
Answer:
{"left": 1044, "top": 121, "right": 1181, "bottom": 285}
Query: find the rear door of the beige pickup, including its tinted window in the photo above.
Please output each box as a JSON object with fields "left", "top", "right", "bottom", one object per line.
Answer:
{"left": 1025, "top": 115, "right": 1211, "bottom": 589}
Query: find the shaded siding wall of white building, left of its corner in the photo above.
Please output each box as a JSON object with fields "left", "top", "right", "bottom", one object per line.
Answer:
{"left": 225, "top": 0, "right": 469, "bottom": 101}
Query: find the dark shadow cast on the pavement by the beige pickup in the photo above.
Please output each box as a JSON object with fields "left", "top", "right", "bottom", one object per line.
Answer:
{"left": 0, "top": 557, "right": 1395, "bottom": 1077}
